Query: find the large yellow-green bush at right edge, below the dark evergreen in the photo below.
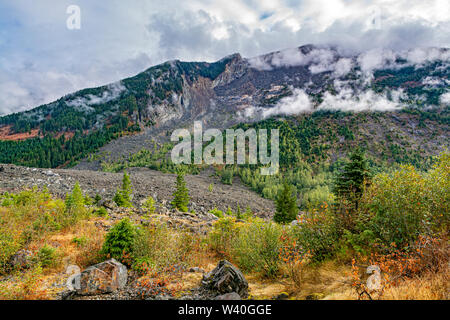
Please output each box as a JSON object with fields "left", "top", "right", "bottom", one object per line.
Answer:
{"left": 357, "top": 153, "right": 450, "bottom": 247}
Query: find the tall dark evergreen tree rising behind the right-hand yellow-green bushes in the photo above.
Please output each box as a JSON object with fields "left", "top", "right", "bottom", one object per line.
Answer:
{"left": 334, "top": 148, "right": 370, "bottom": 205}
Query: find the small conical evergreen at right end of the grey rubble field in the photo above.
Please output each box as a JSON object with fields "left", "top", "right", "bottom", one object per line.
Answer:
{"left": 273, "top": 180, "right": 298, "bottom": 223}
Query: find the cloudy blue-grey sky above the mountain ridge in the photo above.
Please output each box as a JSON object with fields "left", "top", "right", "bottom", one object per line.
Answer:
{"left": 0, "top": 0, "right": 450, "bottom": 115}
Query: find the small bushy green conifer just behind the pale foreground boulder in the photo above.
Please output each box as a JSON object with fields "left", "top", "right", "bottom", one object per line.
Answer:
{"left": 101, "top": 218, "right": 137, "bottom": 264}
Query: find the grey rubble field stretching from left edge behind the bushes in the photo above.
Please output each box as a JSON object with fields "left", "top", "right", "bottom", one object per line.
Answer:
{"left": 0, "top": 165, "right": 274, "bottom": 217}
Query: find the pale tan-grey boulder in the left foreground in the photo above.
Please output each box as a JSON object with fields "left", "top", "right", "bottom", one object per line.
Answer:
{"left": 76, "top": 259, "right": 128, "bottom": 295}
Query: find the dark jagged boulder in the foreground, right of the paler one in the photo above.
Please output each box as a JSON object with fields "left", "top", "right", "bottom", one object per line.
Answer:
{"left": 201, "top": 260, "right": 248, "bottom": 298}
